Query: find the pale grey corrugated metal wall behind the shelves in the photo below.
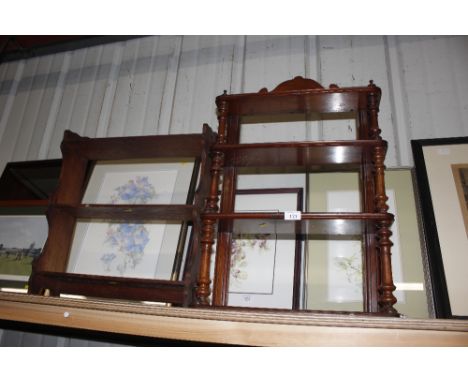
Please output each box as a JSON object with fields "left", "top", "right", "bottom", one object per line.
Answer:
{"left": 0, "top": 36, "right": 468, "bottom": 345}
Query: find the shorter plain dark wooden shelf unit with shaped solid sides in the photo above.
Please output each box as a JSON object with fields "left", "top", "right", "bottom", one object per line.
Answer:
{"left": 29, "top": 125, "right": 216, "bottom": 306}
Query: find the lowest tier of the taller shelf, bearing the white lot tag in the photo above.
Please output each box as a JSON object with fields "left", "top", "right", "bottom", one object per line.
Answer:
{"left": 202, "top": 212, "right": 394, "bottom": 237}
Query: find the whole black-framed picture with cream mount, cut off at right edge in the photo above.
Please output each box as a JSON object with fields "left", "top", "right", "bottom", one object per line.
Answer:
{"left": 411, "top": 137, "right": 468, "bottom": 318}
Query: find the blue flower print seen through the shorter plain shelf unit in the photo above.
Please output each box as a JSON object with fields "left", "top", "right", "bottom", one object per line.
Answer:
{"left": 68, "top": 158, "right": 195, "bottom": 280}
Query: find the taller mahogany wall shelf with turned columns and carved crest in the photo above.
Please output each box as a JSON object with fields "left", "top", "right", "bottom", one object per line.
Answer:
{"left": 197, "top": 77, "right": 398, "bottom": 315}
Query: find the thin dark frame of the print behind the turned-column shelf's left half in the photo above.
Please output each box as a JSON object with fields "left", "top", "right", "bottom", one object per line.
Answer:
{"left": 228, "top": 187, "right": 304, "bottom": 310}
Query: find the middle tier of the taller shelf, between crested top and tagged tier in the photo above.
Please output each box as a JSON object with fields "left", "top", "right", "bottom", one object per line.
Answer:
{"left": 213, "top": 140, "right": 387, "bottom": 171}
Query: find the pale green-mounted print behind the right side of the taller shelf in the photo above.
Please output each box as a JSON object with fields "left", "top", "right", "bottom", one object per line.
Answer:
{"left": 305, "top": 168, "right": 432, "bottom": 318}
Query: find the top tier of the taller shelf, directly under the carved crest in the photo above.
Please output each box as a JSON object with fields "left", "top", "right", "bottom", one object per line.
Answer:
{"left": 216, "top": 87, "right": 380, "bottom": 116}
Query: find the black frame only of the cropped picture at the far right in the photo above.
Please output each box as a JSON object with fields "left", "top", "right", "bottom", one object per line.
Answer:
{"left": 411, "top": 137, "right": 468, "bottom": 319}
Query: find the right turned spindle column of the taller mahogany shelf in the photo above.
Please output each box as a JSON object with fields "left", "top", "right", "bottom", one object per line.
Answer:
{"left": 369, "top": 81, "right": 398, "bottom": 315}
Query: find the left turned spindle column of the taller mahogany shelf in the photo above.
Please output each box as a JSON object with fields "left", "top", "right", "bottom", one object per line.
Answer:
{"left": 196, "top": 97, "right": 227, "bottom": 305}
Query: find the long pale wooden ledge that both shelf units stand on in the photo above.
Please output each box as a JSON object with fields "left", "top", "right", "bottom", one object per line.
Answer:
{"left": 0, "top": 292, "right": 468, "bottom": 346}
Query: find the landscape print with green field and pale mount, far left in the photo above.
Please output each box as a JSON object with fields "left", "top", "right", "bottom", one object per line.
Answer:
{"left": 0, "top": 216, "right": 48, "bottom": 281}
